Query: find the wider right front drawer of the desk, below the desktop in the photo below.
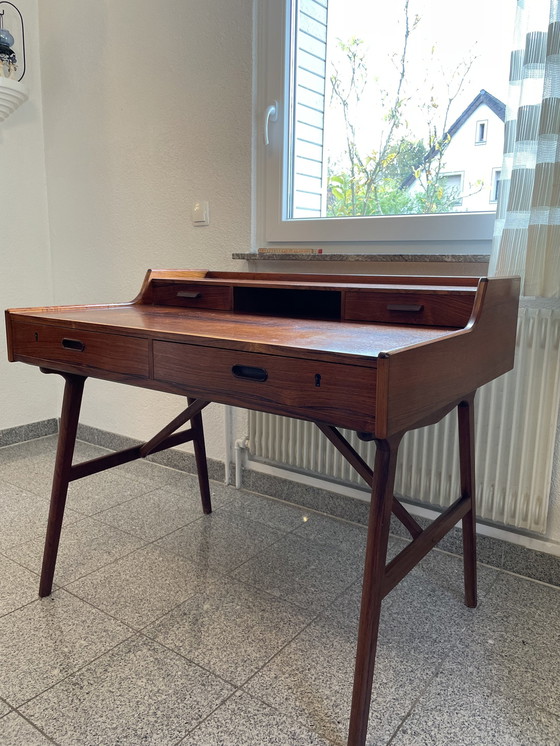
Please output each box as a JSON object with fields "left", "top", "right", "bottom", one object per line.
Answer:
{"left": 154, "top": 341, "right": 376, "bottom": 432}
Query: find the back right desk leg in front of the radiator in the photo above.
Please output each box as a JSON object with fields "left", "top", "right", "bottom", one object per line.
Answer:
{"left": 458, "top": 394, "right": 477, "bottom": 607}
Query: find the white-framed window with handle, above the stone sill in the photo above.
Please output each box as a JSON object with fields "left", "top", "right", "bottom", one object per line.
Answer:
{"left": 257, "top": 0, "right": 514, "bottom": 243}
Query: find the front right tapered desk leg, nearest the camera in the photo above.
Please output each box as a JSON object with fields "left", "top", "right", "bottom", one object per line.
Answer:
{"left": 348, "top": 436, "right": 401, "bottom": 746}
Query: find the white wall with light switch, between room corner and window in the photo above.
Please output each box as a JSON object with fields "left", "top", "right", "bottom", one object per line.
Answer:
{"left": 39, "top": 0, "right": 252, "bottom": 459}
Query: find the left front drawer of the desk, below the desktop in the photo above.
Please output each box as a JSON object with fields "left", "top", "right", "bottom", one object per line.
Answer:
{"left": 12, "top": 321, "right": 149, "bottom": 377}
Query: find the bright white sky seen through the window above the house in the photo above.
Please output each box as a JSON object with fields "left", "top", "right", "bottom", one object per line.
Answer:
{"left": 325, "top": 0, "right": 516, "bottom": 167}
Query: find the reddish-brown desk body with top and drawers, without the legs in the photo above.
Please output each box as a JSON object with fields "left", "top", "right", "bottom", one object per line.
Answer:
{"left": 6, "top": 270, "right": 519, "bottom": 437}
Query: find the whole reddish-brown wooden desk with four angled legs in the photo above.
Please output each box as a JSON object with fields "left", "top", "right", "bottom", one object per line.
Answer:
{"left": 6, "top": 270, "right": 519, "bottom": 746}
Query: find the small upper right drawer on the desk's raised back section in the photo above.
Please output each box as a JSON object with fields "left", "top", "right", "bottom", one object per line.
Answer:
{"left": 344, "top": 290, "right": 474, "bottom": 329}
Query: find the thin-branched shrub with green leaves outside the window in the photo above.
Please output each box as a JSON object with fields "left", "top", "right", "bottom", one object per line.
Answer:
{"left": 327, "top": 11, "right": 470, "bottom": 217}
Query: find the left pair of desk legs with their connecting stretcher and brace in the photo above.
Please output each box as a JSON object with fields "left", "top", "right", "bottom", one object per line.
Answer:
{"left": 39, "top": 369, "right": 212, "bottom": 597}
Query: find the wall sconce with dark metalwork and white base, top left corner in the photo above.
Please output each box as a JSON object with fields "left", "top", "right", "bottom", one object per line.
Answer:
{"left": 0, "top": 0, "right": 29, "bottom": 122}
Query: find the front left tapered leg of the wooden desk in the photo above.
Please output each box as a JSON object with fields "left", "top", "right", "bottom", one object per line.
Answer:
{"left": 39, "top": 373, "right": 86, "bottom": 597}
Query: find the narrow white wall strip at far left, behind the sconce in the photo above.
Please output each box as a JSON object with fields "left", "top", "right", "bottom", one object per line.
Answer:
{"left": 0, "top": 0, "right": 56, "bottom": 430}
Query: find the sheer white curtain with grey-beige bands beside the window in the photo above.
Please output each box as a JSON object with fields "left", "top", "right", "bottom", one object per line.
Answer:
{"left": 489, "top": 0, "right": 560, "bottom": 298}
